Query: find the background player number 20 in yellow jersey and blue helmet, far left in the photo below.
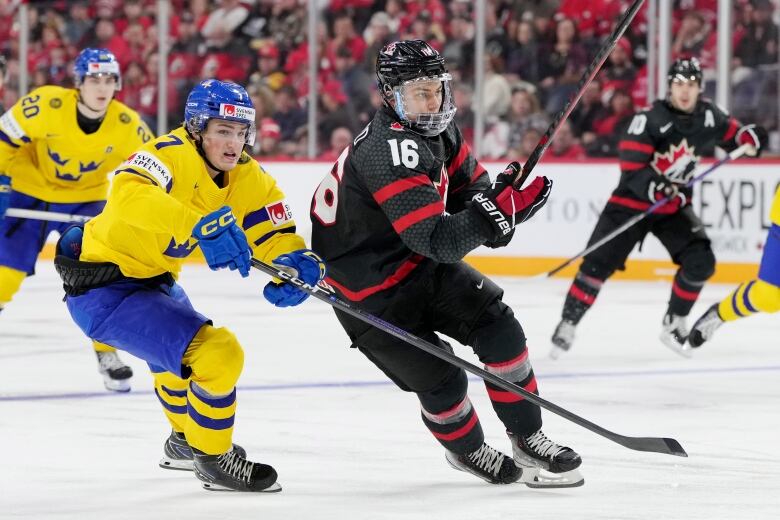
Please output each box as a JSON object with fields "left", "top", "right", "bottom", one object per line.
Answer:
{"left": 0, "top": 49, "right": 154, "bottom": 392}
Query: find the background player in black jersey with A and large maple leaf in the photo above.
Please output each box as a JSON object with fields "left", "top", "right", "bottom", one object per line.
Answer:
{"left": 550, "top": 58, "right": 766, "bottom": 358}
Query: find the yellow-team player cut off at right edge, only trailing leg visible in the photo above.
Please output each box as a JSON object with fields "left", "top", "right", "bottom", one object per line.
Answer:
{"left": 688, "top": 188, "right": 780, "bottom": 347}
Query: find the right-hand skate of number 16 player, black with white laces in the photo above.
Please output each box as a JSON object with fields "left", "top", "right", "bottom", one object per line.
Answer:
{"left": 507, "top": 429, "right": 585, "bottom": 488}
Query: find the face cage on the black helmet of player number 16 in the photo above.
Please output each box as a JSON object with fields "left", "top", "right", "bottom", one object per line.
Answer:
{"left": 391, "top": 72, "right": 457, "bottom": 136}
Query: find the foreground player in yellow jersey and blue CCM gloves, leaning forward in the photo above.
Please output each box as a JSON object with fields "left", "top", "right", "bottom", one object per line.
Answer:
{"left": 55, "top": 80, "right": 325, "bottom": 491}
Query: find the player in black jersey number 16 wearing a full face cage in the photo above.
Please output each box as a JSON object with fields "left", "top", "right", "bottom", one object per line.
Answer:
{"left": 311, "top": 40, "right": 583, "bottom": 487}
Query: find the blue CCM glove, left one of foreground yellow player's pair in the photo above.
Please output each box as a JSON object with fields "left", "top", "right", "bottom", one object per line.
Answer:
{"left": 192, "top": 206, "right": 252, "bottom": 278}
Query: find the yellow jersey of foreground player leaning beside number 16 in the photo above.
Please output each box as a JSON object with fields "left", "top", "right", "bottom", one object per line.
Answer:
{"left": 81, "top": 127, "right": 306, "bottom": 278}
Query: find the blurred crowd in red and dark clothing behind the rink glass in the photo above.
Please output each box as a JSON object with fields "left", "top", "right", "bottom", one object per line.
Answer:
{"left": 0, "top": 0, "right": 778, "bottom": 160}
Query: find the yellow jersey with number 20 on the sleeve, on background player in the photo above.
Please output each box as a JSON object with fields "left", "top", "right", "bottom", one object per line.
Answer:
{"left": 0, "top": 86, "right": 154, "bottom": 203}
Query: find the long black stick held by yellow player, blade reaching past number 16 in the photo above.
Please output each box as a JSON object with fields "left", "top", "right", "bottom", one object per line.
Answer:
{"left": 252, "top": 258, "right": 688, "bottom": 457}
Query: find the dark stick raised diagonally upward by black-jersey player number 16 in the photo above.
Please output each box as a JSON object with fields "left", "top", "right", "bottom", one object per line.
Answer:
{"left": 512, "top": 0, "right": 644, "bottom": 189}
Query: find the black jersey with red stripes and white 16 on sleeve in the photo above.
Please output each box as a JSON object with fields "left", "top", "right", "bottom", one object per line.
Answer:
{"left": 311, "top": 107, "right": 493, "bottom": 306}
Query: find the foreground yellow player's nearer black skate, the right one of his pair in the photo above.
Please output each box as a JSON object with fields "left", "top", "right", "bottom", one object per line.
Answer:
{"left": 193, "top": 449, "right": 282, "bottom": 493}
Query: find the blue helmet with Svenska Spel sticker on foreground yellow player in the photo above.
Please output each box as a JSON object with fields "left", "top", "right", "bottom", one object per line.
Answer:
{"left": 184, "top": 79, "right": 256, "bottom": 146}
